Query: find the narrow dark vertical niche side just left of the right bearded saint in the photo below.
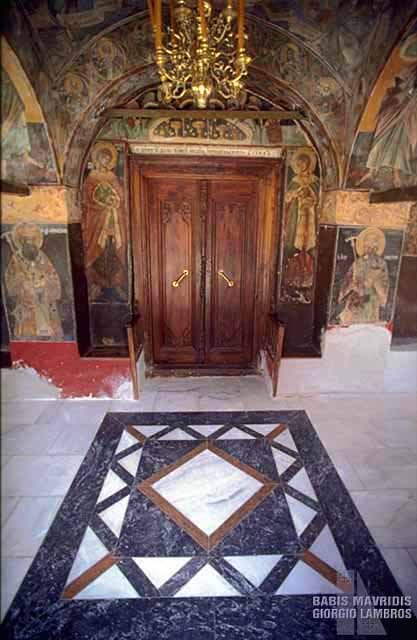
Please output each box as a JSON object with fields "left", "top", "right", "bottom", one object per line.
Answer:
{"left": 313, "top": 226, "right": 337, "bottom": 348}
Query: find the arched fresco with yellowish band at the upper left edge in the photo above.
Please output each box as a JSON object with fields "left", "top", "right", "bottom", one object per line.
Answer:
{"left": 0, "top": 40, "right": 57, "bottom": 184}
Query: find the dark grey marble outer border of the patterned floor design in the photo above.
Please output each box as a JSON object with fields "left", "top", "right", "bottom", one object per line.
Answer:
{"left": 1, "top": 411, "right": 416, "bottom": 640}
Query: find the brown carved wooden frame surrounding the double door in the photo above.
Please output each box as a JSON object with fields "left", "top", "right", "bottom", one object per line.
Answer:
{"left": 129, "top": 154, "right": 283, "bottom": 375}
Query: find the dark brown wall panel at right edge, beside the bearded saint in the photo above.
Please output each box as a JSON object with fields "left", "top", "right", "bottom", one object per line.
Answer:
{"left": 393, "top": 256, "right": 417, "bottom": 345}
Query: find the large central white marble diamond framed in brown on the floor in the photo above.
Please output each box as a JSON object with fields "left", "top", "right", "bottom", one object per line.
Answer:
{"left": 153, "top": 449, "right": 262, "bottom": 535}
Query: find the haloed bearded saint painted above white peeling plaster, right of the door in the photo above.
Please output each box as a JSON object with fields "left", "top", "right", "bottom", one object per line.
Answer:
{"left": 338, "top": 227, "right": 389, "bottom": 324}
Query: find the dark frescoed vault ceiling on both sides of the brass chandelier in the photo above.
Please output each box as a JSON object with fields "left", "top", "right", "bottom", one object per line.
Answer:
{"left": 3, "top": 0, "right": 417, "bottom": 186}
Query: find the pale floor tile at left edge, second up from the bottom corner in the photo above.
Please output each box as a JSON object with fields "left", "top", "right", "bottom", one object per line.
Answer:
{"left": 1, "top": 497, "right": 62, "bottom": 557}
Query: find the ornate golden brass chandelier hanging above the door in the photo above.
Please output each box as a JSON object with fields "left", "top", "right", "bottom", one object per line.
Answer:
{"left": 148, "top": 0, "right": 251, "bottom": 109}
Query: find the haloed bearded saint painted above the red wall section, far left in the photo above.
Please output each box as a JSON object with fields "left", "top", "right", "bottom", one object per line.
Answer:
{"left": 5, "top": 222, "right": 63, "bottom": 338}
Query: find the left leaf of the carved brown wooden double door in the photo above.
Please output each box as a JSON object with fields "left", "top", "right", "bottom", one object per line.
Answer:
{"left": 146, "top": 178, "right": 202, "bottom": 364}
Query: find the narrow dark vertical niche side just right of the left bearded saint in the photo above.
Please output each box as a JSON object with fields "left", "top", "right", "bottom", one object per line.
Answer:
{"left": 68, "top": 223, "right": 90, "bottom": 355}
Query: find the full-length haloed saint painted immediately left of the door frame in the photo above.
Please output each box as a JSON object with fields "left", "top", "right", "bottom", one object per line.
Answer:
{"left": 83, "top": 142, "right": 126, "bottom": 300}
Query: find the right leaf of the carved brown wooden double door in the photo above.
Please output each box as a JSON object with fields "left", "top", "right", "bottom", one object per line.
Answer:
{"left": 205, "top": 179, "right": 257, "bottom": 366}
